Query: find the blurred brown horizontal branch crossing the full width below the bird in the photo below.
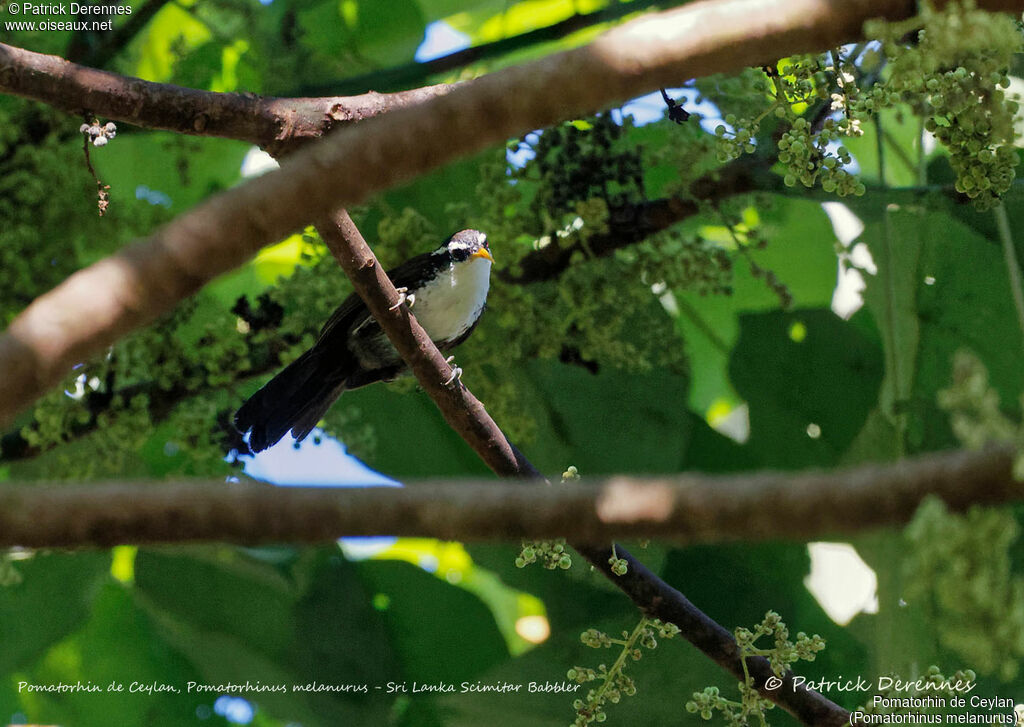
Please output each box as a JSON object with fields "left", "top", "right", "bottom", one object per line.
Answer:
{"left": 0, "top": 450, "right": 1024, "bottom": 548}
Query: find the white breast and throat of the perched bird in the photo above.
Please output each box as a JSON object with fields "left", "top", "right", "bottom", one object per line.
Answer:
{"left": 413, "top": 257, "right": 490, "bottom": 342}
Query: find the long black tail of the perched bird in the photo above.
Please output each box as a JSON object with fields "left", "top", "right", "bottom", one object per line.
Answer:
{"left": 234, "top": 346, "right": 351, "bottom": 453}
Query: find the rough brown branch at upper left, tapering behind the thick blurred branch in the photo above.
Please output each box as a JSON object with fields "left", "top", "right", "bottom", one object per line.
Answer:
{"left": 0, "top": 43, "right": 457, "bottom": 148}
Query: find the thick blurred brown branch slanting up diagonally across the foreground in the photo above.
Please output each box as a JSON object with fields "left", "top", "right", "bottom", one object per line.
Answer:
{"left": 0, "top": 0, "right": 1024, "bottom": 428}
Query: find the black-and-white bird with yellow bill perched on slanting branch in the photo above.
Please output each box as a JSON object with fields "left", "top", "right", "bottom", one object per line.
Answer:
{"left": 234, "top": 229, "right": 495, "bottom": 454}
